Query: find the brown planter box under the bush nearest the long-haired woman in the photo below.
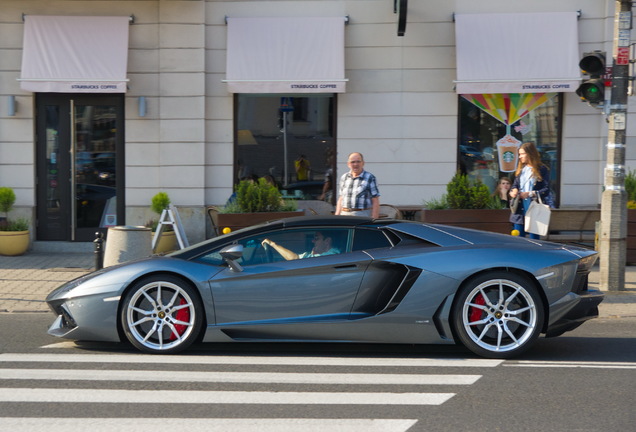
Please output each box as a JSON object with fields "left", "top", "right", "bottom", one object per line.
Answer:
{"left": 422, "top": 209, "right": 512, "bottom": 234}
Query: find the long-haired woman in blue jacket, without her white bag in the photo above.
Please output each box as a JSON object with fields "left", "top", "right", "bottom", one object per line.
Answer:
{"left": 510, "top": 142, "right": 552, "bottom": 239}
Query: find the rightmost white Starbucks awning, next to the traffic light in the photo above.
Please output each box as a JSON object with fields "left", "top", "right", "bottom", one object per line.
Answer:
{"left": 455, "top": 12, "right": 581, "bottom": 94}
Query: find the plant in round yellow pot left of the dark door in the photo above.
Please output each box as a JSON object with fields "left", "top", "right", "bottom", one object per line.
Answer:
{"left": 0, "top": 187, "right": 30, "bottom": 256}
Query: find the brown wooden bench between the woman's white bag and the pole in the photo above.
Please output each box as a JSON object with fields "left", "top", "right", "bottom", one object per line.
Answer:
{"left": 544, "top": 208, "right": 601, "bottom": 247}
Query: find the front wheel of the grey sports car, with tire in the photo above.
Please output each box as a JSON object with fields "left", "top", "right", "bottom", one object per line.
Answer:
{"left": 120, "top": 275, "right": 204, "bottom": 354}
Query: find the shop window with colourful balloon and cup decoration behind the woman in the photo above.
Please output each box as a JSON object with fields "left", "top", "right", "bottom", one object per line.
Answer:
{"left": 457, "top": 93, "right": 563, "bottom": 205}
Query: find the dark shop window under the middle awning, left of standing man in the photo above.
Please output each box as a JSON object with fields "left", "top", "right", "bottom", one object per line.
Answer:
{"left": 234, "top": 94, "right": 336, "bottom": 199}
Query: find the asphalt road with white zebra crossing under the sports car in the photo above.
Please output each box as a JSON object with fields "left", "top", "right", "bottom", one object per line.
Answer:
{"left": 0, "top": 313, "right": 636, "bottom": 432}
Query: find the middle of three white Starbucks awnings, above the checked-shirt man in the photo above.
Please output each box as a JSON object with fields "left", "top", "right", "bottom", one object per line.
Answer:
{"left": 224, "top": 17, "right": 347, "bottom": 93}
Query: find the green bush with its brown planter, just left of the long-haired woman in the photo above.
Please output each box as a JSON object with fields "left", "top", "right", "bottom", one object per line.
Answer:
{"left": 422, "top": 172, "right": 510, "bottom": 234}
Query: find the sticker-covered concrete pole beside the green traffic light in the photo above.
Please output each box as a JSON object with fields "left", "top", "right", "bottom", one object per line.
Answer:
{"left": 599, "top": 0, "right": 632, "bottom": 291}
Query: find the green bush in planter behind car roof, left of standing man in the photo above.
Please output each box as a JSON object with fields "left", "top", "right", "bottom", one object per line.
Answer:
{"left": 217, "top": 178, "right": 303, "bottom": 232}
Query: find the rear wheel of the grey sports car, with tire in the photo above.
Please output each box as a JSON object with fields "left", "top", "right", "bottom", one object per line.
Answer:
{"left": 451, "top": 271, "right": 544, "bottom": 359}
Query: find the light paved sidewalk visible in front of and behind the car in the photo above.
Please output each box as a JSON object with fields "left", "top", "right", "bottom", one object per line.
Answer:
{"left": 0, "top": 251, "right": 636, "bottom": 318}
